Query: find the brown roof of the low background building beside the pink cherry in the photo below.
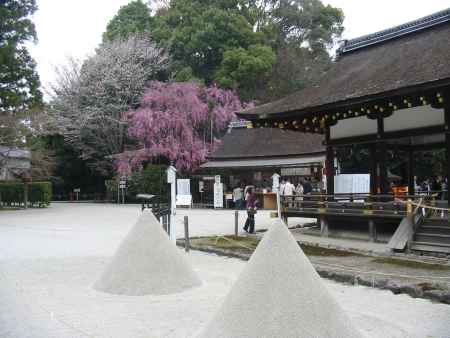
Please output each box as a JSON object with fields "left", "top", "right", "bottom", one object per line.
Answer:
{"left": 209, "top": 128, "right": 325, "bottom": 159}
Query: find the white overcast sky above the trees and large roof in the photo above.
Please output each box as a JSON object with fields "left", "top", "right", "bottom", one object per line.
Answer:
{"left": 31, "top": 0, "right": 450, "bottom": 99}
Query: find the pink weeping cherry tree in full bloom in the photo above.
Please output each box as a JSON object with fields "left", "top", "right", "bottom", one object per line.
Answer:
{"left": 116, "top": 81, "right": 248, "bottom": 173}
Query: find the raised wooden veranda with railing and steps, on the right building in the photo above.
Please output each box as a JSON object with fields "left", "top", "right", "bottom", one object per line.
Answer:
{"left": 281, "top": 192, "right": 450, "bottom": 252}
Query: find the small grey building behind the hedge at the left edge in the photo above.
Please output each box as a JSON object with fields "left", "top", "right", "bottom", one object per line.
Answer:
{"left": 0, "top": 146, "right": 31, "bottom": 181}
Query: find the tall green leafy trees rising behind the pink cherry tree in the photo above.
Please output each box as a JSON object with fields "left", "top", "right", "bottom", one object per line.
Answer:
{"left": 104, "top": 0, "right": 343, "bottom": 102}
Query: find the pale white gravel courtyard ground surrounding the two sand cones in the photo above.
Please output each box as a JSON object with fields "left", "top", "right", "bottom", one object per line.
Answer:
{"left": 0, "top": 204, "right": 450, "bottom": 338}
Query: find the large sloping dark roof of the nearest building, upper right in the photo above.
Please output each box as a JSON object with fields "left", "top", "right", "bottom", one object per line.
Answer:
{"left": 239, "top": 11, "right": 450, "bottom": 118}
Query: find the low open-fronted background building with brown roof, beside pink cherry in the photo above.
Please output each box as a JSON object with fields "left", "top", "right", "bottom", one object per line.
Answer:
{"left": 197, "top": 124, "right": 325, "bottom": 209}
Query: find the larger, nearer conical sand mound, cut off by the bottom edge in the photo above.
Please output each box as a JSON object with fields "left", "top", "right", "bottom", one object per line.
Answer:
{"left": 201, "top": 221, "right": 362, "bottom": 338}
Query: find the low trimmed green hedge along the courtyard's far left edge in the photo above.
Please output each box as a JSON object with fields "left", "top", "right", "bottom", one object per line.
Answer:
{"left": 0, "top": 182, "right": 52, "bottom": 207}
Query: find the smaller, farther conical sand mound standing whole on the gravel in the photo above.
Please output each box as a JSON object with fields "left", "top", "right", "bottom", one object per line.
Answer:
{"left": 94, "top": 211, "right": 201, "bottom": 296}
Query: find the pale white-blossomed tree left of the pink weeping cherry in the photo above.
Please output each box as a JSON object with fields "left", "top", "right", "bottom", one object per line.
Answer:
{"left": 51, "top": 35, "right": 168, "bottom": 175}
